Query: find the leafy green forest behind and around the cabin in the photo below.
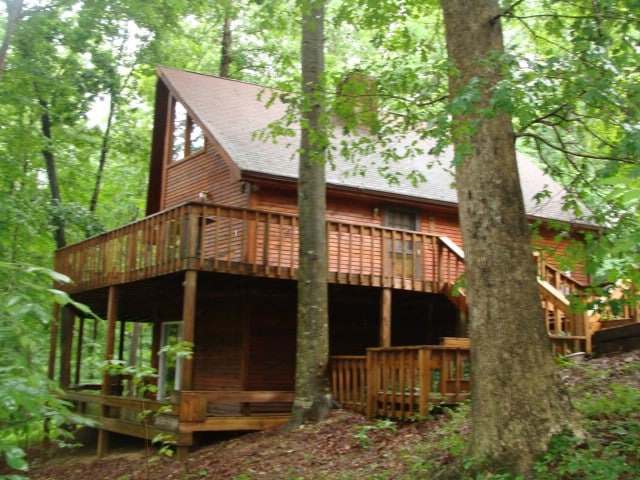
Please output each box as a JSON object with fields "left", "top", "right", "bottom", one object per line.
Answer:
{"left": 0, "top": 0, "right": 640, "bottom": 474}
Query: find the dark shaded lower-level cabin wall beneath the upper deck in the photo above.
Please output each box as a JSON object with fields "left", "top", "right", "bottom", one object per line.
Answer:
{"left": 192, "top": 274, "right": 457, "bottom": 402}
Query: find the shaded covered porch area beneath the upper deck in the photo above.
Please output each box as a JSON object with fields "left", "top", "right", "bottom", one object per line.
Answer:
{"left": 51, "top": 270, "right": 464, "bottom": 455}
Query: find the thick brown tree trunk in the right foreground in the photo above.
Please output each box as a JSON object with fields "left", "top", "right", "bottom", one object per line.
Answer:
{"left": 441, "top": 0, "right": 577, "bottom": 477}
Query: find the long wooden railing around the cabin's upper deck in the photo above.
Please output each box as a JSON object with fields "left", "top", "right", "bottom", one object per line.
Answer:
{"left": 56, "top": 203, "right": 464, "bottom": 292}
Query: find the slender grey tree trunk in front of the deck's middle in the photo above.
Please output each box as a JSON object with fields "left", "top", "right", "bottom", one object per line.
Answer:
{"left": 285, "top": 0, "right": 331, "bottom": 430}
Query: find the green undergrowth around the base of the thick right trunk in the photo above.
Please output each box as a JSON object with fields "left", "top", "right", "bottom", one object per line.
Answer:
{"left": 394, "top": 362, "right": 640, "bottom": 480}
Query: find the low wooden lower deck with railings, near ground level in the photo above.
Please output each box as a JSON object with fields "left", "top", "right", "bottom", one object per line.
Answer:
{"left": 63, "top": 339, "right": 471, "bottom": 456}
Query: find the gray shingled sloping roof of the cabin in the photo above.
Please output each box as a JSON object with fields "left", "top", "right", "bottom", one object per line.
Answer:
{"left": 158, "top": 67, "right": 586, "bottom": 224}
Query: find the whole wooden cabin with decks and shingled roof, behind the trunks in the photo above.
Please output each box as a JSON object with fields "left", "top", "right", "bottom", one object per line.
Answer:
{"left": 49, "top": 67, "right": 637, "bottom": 454}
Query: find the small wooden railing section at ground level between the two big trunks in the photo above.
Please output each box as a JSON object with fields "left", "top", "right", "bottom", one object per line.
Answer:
{"left": 331, "top": 346, "right": 471, "bottom": 419}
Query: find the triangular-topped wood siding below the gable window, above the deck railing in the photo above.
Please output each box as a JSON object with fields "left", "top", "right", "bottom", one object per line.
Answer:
{"left": 163, "top": 140, "right": 249, "bottom": 208}
